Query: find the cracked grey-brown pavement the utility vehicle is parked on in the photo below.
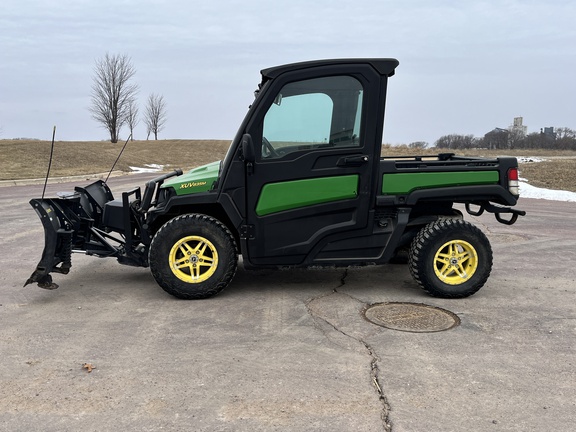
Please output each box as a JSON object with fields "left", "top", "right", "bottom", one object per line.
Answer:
{"left": 0, "top": 176, "right": 576, "bottom": 432}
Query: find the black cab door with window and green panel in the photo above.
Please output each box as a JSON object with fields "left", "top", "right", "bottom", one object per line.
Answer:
{"left": 245, "top": 65, "right": 382, "bottom": 265}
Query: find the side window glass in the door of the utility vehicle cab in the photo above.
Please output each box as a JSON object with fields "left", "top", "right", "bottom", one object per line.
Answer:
{"left": 262, "top": 76, "right": 363, "bottom": 159}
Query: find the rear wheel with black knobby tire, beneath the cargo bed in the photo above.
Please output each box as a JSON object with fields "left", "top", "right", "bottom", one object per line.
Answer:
{"left": 409, "top": 219, "right": 492, "bottom": 298}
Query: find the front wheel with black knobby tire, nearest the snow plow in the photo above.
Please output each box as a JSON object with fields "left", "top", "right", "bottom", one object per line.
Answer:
{"left": 148, "top": 214, "right": 238, "bottom": 300}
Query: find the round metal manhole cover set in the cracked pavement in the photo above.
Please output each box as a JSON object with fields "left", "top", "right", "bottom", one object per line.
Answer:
{"left": 364, "top": 303, "right": 460, "bottom": 333}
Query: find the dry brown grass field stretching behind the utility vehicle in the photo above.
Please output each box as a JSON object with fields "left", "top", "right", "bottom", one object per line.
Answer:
{"left": 0, "top": 140, "right": 576, "bottom": 192}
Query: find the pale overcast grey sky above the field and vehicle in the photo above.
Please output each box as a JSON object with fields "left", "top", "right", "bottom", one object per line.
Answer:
{"left": 0, "top": 0, "right": 576, "bottom": 144}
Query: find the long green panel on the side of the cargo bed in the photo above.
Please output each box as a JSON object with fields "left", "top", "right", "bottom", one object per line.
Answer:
{"left": 382, "top": 171, "right": 499, "bottom": 195}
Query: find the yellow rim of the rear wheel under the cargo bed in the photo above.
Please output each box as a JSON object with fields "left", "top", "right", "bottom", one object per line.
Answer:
{"left": 434, "top": 240, "right": 478, "bottom": 285}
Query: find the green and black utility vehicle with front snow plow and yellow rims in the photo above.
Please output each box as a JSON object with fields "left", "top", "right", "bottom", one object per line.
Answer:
{"left": 27, "top": 59, "right": 524, "bottom": 299}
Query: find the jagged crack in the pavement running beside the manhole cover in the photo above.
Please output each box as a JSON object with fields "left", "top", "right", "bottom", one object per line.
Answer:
{"left": 306, "top": 268, "right": 392, "bottom": 432}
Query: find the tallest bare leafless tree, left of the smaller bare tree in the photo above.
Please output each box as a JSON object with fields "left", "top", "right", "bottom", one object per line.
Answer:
{"left": 90, "top": 53, "right": 138, "bottom": 143}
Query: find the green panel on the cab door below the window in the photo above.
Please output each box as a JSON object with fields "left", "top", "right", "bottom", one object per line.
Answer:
{"left": 256, "top": 175, "right": 358, "bottom": 216}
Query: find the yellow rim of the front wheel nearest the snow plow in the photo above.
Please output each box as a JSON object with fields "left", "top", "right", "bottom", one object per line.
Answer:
{"left": 168, "top": 236, "right": 218, "bottom": 283}
